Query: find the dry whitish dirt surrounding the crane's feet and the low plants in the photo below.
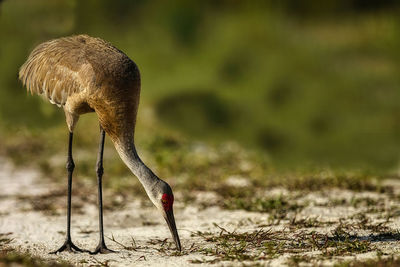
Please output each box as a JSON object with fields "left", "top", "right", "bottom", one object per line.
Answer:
{"left": 0, "top": 159, "right": 400, "bottom": 266}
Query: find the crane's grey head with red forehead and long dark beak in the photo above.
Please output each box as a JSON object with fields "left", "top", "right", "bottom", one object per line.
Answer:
{"left": 150, "top": 180, "right": 181, "bottom": 251}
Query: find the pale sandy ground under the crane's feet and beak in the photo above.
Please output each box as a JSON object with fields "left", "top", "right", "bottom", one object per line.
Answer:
{"left": 0, "top": 159, "right": 400, "bottom": 266}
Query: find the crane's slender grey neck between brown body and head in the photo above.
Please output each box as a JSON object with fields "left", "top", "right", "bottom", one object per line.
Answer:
{"left": 114, "top": 136, "right": 160, "bottom": 196}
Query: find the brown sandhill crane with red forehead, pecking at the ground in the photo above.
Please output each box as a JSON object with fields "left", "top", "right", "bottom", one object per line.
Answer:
{"left": 19, "top": 34, "right": 182, "bottom": 254}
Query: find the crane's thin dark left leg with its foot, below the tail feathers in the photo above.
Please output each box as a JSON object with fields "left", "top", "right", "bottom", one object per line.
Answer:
{"left": 51, "top": 132, "right": 89, "bottom": 254}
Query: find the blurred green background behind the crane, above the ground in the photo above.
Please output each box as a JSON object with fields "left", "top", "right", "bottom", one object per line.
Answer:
{"left": 0, "top": 0, "right": 400, "bottom": 175}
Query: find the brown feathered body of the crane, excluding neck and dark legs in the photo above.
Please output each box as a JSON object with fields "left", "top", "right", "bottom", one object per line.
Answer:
{"left": 19, "top": 35, "right": 140, "bottom": 139}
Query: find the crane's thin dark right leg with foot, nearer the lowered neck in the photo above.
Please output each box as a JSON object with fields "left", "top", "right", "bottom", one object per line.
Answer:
{"left": 91, "top": 126, "right": 115, "bottom": 254}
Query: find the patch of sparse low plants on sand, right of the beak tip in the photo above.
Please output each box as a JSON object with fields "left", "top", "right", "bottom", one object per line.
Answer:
{"left": 188, "top": 225, "right": 382, "bottom": 264}
